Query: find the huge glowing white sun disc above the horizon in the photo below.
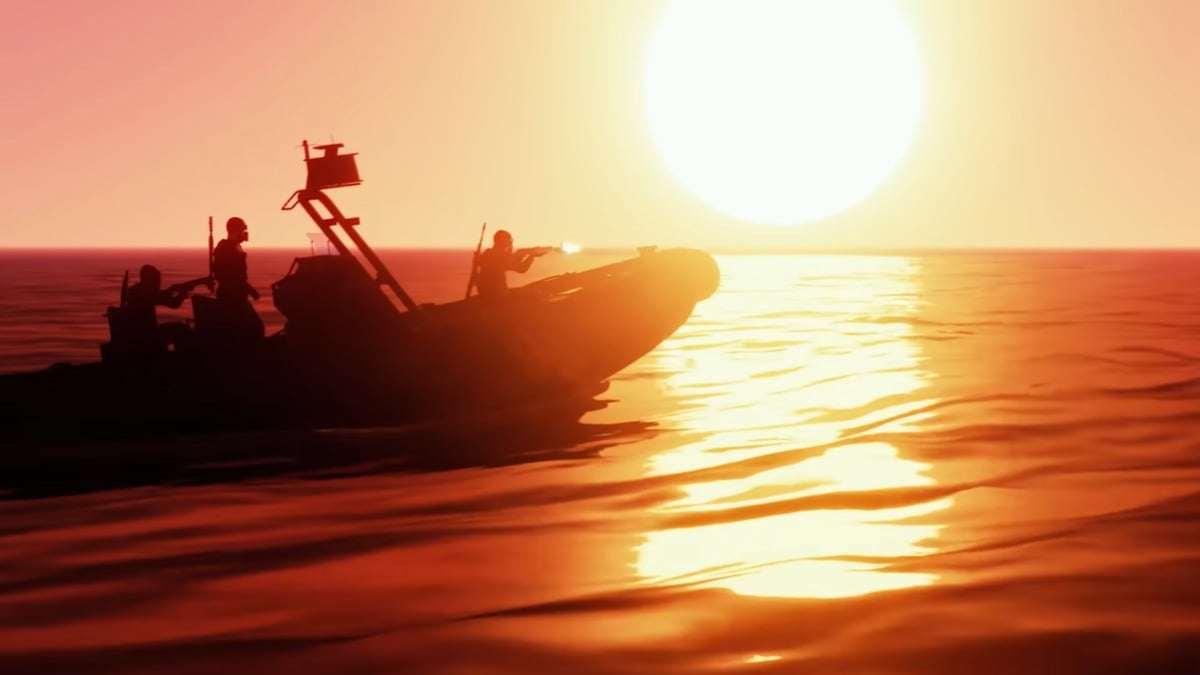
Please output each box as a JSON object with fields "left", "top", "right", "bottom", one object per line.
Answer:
{"left": 646, "top": 0, "right": 920, "bottom": 225}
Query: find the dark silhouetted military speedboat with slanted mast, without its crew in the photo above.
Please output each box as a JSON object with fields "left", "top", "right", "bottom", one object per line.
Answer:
{"left": 0, "top": 142, "right": 720, "bottom": 442}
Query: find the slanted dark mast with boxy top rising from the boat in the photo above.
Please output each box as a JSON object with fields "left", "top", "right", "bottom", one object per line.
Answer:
{"left": 283, "top": 141, "right": 420, "bottom": 312}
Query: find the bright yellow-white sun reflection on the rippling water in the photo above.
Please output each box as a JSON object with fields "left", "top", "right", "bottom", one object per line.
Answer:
{"left": 636, "top": 256, "right": 950, "bottom": 598}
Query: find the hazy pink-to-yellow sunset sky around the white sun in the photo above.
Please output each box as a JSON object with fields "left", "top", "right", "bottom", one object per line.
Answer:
{"left": 0, "top": 0, "right": 1200, "bottom": 250}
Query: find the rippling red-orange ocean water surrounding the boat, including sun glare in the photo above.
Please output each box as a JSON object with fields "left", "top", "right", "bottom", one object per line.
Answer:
{"left": 0, "top": 245, "right": 1200, "bottom": 675}
